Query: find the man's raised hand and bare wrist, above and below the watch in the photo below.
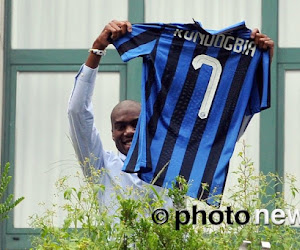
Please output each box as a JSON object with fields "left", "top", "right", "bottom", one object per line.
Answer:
{"left": 85, "top": 20, "right": 132, "bottom": 69}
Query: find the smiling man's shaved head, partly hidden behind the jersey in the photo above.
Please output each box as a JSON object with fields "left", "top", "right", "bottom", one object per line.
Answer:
{"left": 110, "top": 100, "right": 141, "bottom": 155}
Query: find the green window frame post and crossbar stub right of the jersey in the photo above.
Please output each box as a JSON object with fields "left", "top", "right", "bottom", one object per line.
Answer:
{"left": 260, "top": 0, "right": 300, "bottom": 196}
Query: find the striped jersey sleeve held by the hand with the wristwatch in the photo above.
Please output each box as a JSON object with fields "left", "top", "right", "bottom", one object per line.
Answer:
{"left": 113, "top": 24, "right": 162, "bottom": 62}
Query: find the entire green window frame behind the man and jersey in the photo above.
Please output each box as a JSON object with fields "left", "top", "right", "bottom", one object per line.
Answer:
{"left": 0, "top": 0, "right": 300, "bottom": 249}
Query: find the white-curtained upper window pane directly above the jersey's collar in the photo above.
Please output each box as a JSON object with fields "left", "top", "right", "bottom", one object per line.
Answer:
{"left": 145, "top": 0, "right": 261, "bottom": 29}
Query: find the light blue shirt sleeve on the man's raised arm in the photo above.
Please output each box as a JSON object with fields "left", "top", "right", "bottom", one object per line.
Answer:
{"left": 68, "top": 65, "right": 106, "bottom": 174}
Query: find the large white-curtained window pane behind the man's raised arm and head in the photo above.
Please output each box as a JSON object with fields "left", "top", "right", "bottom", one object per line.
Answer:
{"left": 14, "top": 72, "right": 120, "bottom": 228}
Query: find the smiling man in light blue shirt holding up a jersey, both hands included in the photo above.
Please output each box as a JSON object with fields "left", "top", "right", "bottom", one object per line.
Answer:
{"left": 68, "top": 20, "right": 274, "bottom": 208}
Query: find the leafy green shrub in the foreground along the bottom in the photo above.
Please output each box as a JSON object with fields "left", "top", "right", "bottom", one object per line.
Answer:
{"left": 32, "top": 146, "right": 300, "bottom": 249}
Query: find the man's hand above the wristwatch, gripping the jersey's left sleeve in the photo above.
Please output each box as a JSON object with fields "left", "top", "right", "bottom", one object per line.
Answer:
{"left": 93, "top": 20, "right": 132, "bottom": 49}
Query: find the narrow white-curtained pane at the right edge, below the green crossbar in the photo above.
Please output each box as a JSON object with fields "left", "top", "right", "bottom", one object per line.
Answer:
{"left": 284, "top": 70, "right": 300, "bottom": 208}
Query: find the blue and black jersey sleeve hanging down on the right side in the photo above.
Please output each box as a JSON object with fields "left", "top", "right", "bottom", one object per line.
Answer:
{"left": 247, "top": 51, "right": 270, "bottom": 115}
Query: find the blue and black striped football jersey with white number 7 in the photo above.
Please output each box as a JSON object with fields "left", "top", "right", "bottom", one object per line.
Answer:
{"left": 114, "top": 22, "right": 270, "bottom": 204}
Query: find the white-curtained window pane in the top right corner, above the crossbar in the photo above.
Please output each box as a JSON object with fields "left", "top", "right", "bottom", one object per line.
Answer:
{"left": 278, "top": 0, "right": 300, "bottom": 47}
